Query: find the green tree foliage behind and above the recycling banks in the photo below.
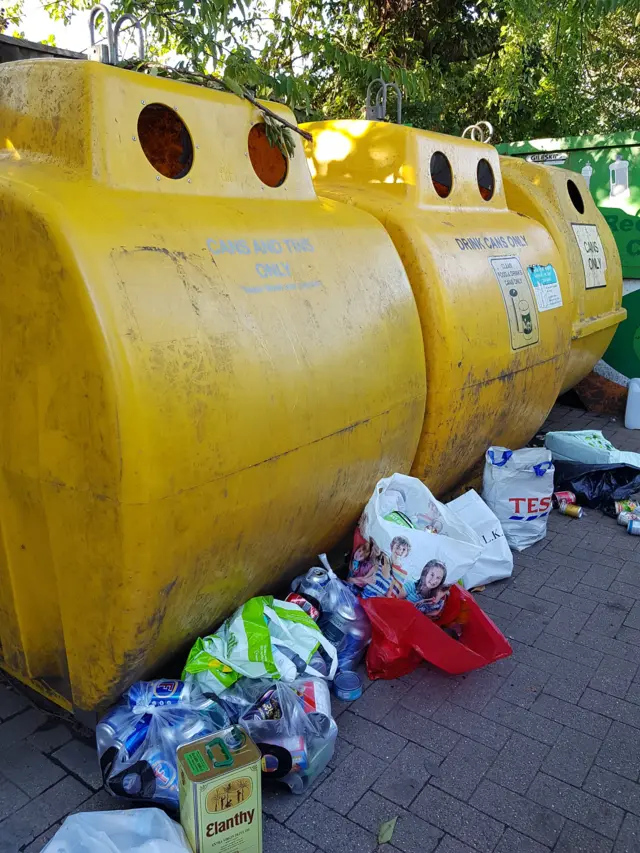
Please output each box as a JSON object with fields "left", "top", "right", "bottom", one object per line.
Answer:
{"left": 22, "top": 0, "right": 640, "bottom": 139}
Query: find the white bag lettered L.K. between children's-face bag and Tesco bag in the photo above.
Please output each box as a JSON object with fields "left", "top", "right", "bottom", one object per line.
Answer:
{"left": 447, "top": 489, "right": 513, "bottom": 589}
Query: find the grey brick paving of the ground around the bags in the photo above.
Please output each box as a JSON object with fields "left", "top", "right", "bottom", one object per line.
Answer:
{"left": 0, "top": 406, "right": 640, "bottom": 853}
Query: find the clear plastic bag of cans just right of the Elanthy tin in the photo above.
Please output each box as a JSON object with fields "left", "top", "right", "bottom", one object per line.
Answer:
{"left": 236, "top": 678, "right": 338, "bottom": 794}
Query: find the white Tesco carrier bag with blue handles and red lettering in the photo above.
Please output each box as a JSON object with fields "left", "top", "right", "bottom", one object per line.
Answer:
{"left": 482, "top": 447, "right": 554, "bottom": 551}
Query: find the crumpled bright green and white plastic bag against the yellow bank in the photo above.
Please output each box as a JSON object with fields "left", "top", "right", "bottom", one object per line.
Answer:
{"left": 182, "top": 595, "right": 338, "bottom": 696}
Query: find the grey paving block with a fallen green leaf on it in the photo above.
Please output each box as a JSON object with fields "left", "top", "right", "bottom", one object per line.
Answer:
{"left": 349, "top": 791, "right": 442, "bottom": 853}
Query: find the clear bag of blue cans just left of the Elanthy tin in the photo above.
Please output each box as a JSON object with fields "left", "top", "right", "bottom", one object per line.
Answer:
{"left": 96, "top": 679, "right": 230, "bottom": 809}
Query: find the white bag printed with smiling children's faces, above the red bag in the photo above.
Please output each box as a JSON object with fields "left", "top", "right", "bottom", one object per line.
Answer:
{"left": 347, "top": 474, "right": 482, "bottom": 618}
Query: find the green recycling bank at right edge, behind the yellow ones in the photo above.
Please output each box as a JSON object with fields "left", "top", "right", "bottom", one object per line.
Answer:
{"left": 497, "top": 131, "right": 640, "bottom": 378}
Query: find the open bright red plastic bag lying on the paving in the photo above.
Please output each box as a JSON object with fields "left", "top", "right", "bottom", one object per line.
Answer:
{"left": 362, "top": 584, "right": 512, "bottom": 679}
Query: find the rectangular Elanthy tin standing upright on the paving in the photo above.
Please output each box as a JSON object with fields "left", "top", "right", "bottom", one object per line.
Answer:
{"left": 178, "top": 726, "right": 262, "bottom": 853}
